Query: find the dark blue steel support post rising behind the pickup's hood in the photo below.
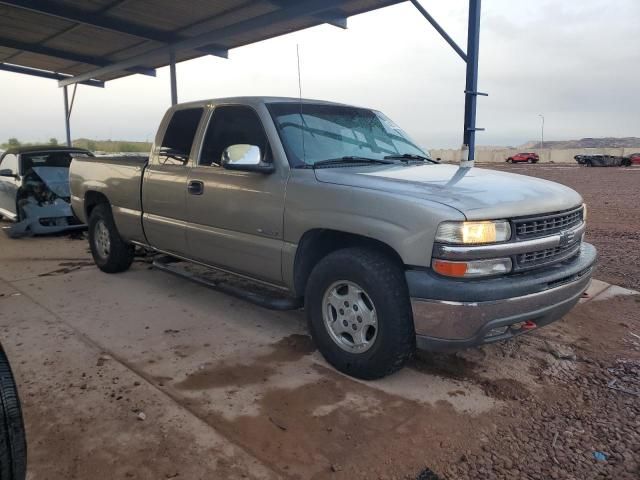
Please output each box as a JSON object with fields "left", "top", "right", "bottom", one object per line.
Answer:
{"left": 461, "top": 0, "right": 481, "bottom": 167}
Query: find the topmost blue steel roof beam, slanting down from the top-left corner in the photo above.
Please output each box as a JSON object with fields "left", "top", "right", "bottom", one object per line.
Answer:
{"left": 0, "top": 0, "right": 226, "bottom": 58}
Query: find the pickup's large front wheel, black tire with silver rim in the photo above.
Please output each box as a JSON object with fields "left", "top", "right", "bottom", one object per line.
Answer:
{"left": 305, "top": 248, "right": 416, "bottom": 380}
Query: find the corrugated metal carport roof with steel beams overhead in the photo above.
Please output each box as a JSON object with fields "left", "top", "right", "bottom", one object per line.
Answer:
{"left": 0, "top": 0, "right": 403, "bottom": 85}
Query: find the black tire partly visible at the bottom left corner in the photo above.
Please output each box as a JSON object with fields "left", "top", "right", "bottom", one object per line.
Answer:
{"left": 0, "top": 347, "right": 27, "bottom": 480}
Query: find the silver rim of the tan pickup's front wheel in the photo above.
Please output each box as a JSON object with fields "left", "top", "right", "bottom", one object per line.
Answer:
{"left": 322, "top": 280, "right": 378, "bottom": 353}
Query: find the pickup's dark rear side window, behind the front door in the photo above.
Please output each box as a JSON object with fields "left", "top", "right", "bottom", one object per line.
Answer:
{"left": 158, "top": 108, "right": 204, "bottom": 165}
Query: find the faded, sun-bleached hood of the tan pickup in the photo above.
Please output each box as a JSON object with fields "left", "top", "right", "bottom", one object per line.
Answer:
{"left": 315, "top": 164, "right": 582, "bottom": 220}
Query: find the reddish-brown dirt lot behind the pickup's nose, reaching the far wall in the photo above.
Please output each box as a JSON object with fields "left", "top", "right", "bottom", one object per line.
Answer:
{"left": 480, "top": 164, "right": 640, "bottom": 290}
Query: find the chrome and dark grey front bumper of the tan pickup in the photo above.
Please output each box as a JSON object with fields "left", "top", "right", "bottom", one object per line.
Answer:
{"left": 406, "top": 243, "right": 597, "bottom": 350}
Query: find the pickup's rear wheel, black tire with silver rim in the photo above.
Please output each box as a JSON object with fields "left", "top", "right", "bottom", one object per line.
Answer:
{"left": 89, "top": 203, "right": 134, "bottom": 273}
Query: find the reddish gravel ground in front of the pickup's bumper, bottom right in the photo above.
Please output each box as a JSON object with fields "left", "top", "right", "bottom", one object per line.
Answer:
{"left": 413, "top": 290, "right": 640, "bottom": 480}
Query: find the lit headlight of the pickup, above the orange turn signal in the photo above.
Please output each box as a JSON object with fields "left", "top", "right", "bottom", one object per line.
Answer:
{"left": 436, "top": 220, "right": 511, "bottom": 245}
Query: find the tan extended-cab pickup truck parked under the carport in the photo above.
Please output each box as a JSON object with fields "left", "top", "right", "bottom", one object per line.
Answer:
{"left": 70, "top": 97, "right": 596, "bottom": 379}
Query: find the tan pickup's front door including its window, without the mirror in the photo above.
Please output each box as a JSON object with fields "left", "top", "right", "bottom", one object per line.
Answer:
{"left": 186, "top": 105, "right": 287, "bottom": 284}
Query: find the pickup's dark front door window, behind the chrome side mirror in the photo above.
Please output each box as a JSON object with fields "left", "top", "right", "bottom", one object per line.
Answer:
{"left": 199, "top": 106, "right": 271, "bottom": 166}
